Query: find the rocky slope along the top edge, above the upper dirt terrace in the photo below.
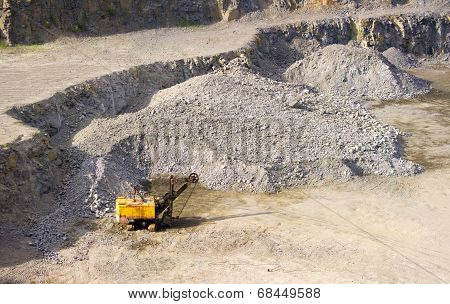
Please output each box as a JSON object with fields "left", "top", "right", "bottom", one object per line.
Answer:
{"left": 0, "top": 0, "right": 445, "bottom": 44}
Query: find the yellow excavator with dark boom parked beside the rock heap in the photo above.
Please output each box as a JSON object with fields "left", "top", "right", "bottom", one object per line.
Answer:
{"left": 116, "top": 173, "right": 199, "bottom": 232}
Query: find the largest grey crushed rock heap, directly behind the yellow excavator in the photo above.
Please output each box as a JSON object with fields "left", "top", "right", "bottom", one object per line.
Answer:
{"left": 73, "top": 67, "right": 420, "bottom": 191}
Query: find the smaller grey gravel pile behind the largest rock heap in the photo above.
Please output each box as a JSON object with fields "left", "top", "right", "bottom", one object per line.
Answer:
{"left": 284, "top": 44, "right": 430, "bottom": 99}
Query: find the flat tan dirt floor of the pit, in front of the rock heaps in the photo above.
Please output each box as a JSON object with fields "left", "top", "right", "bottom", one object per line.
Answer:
{"left": 0, "top": 66, "right": 450, "bottom": 283}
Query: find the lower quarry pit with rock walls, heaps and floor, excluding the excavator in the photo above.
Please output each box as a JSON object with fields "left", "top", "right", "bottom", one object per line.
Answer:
{"left": 0, "top": 1, "right": 450, "bottom": 283}
